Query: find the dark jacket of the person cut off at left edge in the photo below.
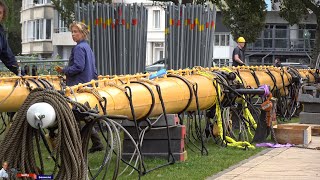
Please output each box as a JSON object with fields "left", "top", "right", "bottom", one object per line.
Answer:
{"left": 0, "top": 24, "right": 19, "bottom": 75}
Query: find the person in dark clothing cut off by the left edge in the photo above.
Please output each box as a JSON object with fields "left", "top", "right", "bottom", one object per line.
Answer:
{"left": 0, "top": 0, "right": 19, "bottom": 75}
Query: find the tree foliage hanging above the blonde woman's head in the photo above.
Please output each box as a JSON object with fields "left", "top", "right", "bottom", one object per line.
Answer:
{"left": 52, "top": 0, "right": 112, "bottom": 24}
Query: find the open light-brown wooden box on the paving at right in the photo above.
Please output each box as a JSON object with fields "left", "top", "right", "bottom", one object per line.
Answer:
{"left": 273, "top": 124, "right": 311, "bottom": 145}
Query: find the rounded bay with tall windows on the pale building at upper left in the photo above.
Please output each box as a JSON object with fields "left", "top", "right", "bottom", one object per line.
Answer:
{"left": 20, "top": 0, "right": 54, "bottom": 56}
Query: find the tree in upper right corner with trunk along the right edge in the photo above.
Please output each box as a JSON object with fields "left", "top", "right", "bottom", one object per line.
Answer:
{"left": 280, "top": 0, "right": 320, "bottom": 67}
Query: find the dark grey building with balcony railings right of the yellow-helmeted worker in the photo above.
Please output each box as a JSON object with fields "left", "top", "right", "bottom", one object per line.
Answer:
{"left": 246, "top": 11, "right": 317, "bottom": 65}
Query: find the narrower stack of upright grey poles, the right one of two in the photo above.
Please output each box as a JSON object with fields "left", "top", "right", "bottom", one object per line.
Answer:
{"left": 165, "top": 4, "right": 216, "bottom": 69}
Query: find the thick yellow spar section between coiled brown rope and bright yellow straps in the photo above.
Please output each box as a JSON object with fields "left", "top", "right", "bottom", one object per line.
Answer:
{"left": 67, "top": 71, "right": 217, "bottom": 120}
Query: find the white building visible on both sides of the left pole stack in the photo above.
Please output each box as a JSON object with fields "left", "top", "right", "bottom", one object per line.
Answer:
{"left": 20, "top": 0, "right": 165, "bottom": 65}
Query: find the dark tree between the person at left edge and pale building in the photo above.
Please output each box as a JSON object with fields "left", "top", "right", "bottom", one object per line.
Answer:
{"left": 4, "top": 0, "right": 22, "bottom": 55}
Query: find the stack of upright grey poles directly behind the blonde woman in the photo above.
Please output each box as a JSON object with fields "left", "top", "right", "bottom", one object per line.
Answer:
{"left": 75, "top": 2, "right": 148, "bottom": 75}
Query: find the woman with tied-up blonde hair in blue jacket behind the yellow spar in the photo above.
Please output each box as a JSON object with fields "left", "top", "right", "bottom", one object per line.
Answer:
{"left": 55, "top": 22, "right": 103, "bottom": 153}
